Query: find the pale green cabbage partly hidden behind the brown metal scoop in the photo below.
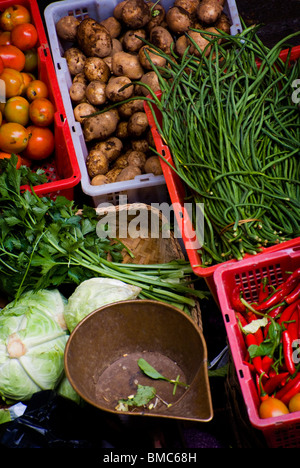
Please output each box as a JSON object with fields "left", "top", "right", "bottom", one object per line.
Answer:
{"left": 64, "top": 278, "right": 141, "bottom": 332}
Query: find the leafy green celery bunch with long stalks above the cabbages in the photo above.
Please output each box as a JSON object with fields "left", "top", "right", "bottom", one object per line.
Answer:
{"left": 0, "top": 157, "right": 207, "bottom": 308}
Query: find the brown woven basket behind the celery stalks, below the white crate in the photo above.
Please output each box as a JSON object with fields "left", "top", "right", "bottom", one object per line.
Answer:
{"left": 96, "top": 203, "right": 202, "bottom": 329}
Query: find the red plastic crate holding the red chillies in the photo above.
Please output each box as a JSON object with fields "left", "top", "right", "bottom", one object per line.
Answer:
{"left": 214, "top": 242, "right": 300, "bottom": 448}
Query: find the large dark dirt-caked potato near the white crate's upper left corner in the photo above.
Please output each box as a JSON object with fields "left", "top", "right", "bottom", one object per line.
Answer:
{"left": 77, "top": 18, "right": 112, "bottom": 58}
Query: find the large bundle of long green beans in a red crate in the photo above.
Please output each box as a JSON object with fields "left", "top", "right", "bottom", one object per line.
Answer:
{"left": 144, "top": 27, "right": 300, "bottom": 266}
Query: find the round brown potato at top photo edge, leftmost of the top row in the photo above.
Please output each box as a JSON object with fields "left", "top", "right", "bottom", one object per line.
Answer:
{"left": 121, "top": 0, "right": 151, "bottom": 29}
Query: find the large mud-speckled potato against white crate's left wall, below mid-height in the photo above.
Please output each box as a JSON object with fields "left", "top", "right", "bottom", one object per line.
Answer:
{"left": 83, "top": 109, "right": 119, "bottom": 141}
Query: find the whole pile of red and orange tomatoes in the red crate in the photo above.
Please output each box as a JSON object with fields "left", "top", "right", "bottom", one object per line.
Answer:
{"left": 0, "top": 5, "right": 55, "bottom": 167}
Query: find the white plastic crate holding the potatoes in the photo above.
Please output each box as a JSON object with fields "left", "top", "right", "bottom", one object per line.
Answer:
{"left": 44, "top": 0, "right": 241, "bottom": 206}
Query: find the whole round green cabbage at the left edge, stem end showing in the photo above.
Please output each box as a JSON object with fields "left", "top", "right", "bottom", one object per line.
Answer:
{"left": 0, "top": 290, "right": 69, "bottom": 400}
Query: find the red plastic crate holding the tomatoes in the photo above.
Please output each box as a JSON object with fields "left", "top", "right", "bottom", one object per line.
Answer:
{"left": 0, "top": 0, "right": 81, "bottom": 200}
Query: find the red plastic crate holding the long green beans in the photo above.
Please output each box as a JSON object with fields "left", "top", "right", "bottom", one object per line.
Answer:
{"left": 145, "top": 46, "right": 300, "bottom": 302}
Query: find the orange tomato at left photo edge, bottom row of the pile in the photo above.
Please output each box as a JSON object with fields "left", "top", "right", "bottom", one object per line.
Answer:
{"left": 0, "top": 122, "right": 28, "bottom": 154}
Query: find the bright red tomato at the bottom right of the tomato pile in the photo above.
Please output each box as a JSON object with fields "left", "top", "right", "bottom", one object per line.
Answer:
{"left": 23, "top": 125, "right": 55, "bottom": 160}
